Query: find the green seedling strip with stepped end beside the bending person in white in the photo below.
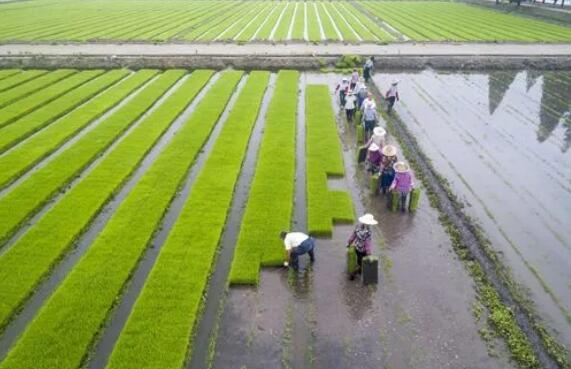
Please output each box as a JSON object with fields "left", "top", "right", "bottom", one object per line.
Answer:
{"left": 229, "top": 71, "right": 299, "bottom": 284}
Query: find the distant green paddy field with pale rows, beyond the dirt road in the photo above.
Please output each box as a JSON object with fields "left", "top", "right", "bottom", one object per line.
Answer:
{"left": 0, "top": 0, "right": 571, "bottom": 43}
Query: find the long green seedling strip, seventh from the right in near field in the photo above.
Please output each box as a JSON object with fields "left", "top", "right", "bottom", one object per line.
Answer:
{"left": 0, "top": 70, "right": 157, "bottom": 188}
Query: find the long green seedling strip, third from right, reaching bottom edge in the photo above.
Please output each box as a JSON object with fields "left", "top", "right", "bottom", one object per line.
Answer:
{"left": 107, "top": 72, "right": 269, "bottom": 369}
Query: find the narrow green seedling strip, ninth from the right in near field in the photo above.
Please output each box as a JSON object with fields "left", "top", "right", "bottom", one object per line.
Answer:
{"left": 0, "top": 70, "right": 104, "bottom": 129}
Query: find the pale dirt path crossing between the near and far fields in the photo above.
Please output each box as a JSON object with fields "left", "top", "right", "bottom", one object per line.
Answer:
{"left": 0, "top": 43, "right": 571, "bottom": 56}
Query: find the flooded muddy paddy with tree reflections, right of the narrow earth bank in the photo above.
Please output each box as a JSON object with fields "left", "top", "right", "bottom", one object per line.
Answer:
{"left": 375, "top": 71, "right": 571, "bottom": 347}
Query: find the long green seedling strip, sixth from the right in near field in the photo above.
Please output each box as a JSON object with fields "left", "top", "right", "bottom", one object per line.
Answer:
{"left": 0, "top": 70, "right": 165, "bottom": 245}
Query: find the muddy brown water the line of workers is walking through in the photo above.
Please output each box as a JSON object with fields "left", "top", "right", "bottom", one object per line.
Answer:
{"left": 214, "top": 74, "right": 513, "bottom": 369}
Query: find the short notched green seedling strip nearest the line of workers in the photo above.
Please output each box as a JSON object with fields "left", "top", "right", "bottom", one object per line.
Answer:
{"left": 305, "top": 85, "right": 354, "bottom": 236}
